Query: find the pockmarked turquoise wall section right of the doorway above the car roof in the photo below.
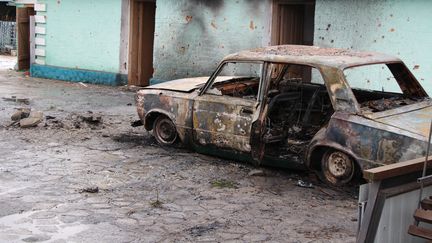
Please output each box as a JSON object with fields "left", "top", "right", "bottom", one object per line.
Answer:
{"left": 314, "top": 0, "right": 432, "bottom": 95}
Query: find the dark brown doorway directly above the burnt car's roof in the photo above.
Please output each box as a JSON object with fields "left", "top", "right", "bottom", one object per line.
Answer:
{"left": 272, "top": 0, "right": 315, "bottom": 45}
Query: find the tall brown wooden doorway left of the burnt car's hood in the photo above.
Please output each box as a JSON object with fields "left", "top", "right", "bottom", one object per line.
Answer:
{"left": 128, "top": 0, "right": 156, "bottom": 86}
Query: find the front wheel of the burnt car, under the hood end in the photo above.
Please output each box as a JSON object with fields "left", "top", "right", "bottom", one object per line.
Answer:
{"left": 153, "top": 115, "right": 178, "bottom": 146}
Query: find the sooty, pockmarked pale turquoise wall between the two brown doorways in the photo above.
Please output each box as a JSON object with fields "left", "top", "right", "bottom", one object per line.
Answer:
{"left": 154, "top": 0, "right": 271, "bottom": 81}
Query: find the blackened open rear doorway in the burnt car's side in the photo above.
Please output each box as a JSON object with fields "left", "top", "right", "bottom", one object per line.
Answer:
{"left": 263, "top": 64, "right": 334, "bottom": 163}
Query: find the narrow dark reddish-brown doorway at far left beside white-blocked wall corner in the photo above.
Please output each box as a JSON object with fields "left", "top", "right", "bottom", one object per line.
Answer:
{"left": 16, "top": 8, "right": 35, "bottom": 70}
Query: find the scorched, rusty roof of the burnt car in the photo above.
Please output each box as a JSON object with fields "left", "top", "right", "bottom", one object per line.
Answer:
{"left": 224, "top": 45, "right": 401, "bottom": 69}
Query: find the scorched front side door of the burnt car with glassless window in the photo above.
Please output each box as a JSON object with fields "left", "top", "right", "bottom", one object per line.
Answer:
{"left": 193, "top": 63, "right": 262, "bottom": 153}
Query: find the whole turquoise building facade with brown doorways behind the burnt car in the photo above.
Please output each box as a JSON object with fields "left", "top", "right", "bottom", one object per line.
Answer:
{"left": 11, "top": 0, "right": 432, "bottom": 93}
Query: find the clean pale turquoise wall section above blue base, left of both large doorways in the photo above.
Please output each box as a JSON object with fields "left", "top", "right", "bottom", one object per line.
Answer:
{"left": 39, "top": 0, "right": 121, "bottom": 73}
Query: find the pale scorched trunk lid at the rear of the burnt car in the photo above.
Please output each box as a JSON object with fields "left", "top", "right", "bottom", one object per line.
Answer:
{"left": 372, "top": 101, "right": 432, "bottom": 138}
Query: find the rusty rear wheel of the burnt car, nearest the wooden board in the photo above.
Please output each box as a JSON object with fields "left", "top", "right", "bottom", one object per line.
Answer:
{"left": 320, "top": 149, "right": 355, "bottom": 186}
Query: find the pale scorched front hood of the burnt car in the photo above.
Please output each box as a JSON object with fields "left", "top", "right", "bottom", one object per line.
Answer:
{"left": 145, "top": 76, "right": 237, "bottom": 92}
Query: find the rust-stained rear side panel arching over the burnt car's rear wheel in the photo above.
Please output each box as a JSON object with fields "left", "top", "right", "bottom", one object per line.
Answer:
{"left": 306, "top": 113, "right": 427, "bottom": 170}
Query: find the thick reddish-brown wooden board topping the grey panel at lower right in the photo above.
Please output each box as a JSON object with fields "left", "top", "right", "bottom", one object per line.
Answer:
{"left": 363, "top": 158, "right": 432, "bottom": 181}
